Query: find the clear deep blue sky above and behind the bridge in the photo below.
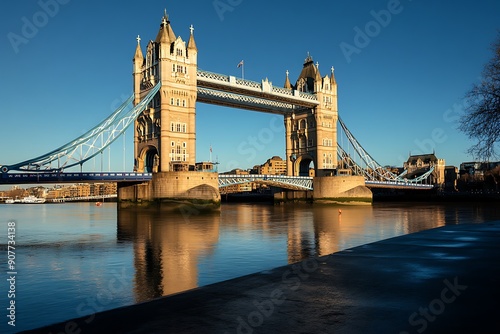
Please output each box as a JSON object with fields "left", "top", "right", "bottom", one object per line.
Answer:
{"left": 0, "top": 0, "right": 500, "bottom": 170}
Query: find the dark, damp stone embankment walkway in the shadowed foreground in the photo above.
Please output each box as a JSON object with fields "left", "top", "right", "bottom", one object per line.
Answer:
{"left": 20, "top": 221, "right": 500, "bottom": 334}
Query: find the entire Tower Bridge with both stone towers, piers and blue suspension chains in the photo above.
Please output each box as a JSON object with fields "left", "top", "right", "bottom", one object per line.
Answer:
{"left": 0, "top": 9, "right": 434, "bottom": 203}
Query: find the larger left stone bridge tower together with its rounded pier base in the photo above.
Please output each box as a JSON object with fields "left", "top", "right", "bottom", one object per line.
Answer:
{"left": 118, "top": 11, "right": 220, "bottom": 209}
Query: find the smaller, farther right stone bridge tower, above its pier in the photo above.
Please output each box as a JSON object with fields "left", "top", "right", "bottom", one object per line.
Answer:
{"left": 285, "top": 55, "right": 338, "bottom": 176}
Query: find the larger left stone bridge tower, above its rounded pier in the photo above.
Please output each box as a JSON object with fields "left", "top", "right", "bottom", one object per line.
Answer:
{"left": 133, "top": 11, "right": 198, "bottom": 172}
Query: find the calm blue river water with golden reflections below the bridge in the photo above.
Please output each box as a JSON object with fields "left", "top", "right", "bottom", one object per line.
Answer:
{"left": 0, "top": 203, "right": 500, "bottom": 333}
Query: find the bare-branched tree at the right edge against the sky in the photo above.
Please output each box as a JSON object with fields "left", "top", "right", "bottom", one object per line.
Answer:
{"left": 458, "top": 31, "right": 500, "bottom": 161}
